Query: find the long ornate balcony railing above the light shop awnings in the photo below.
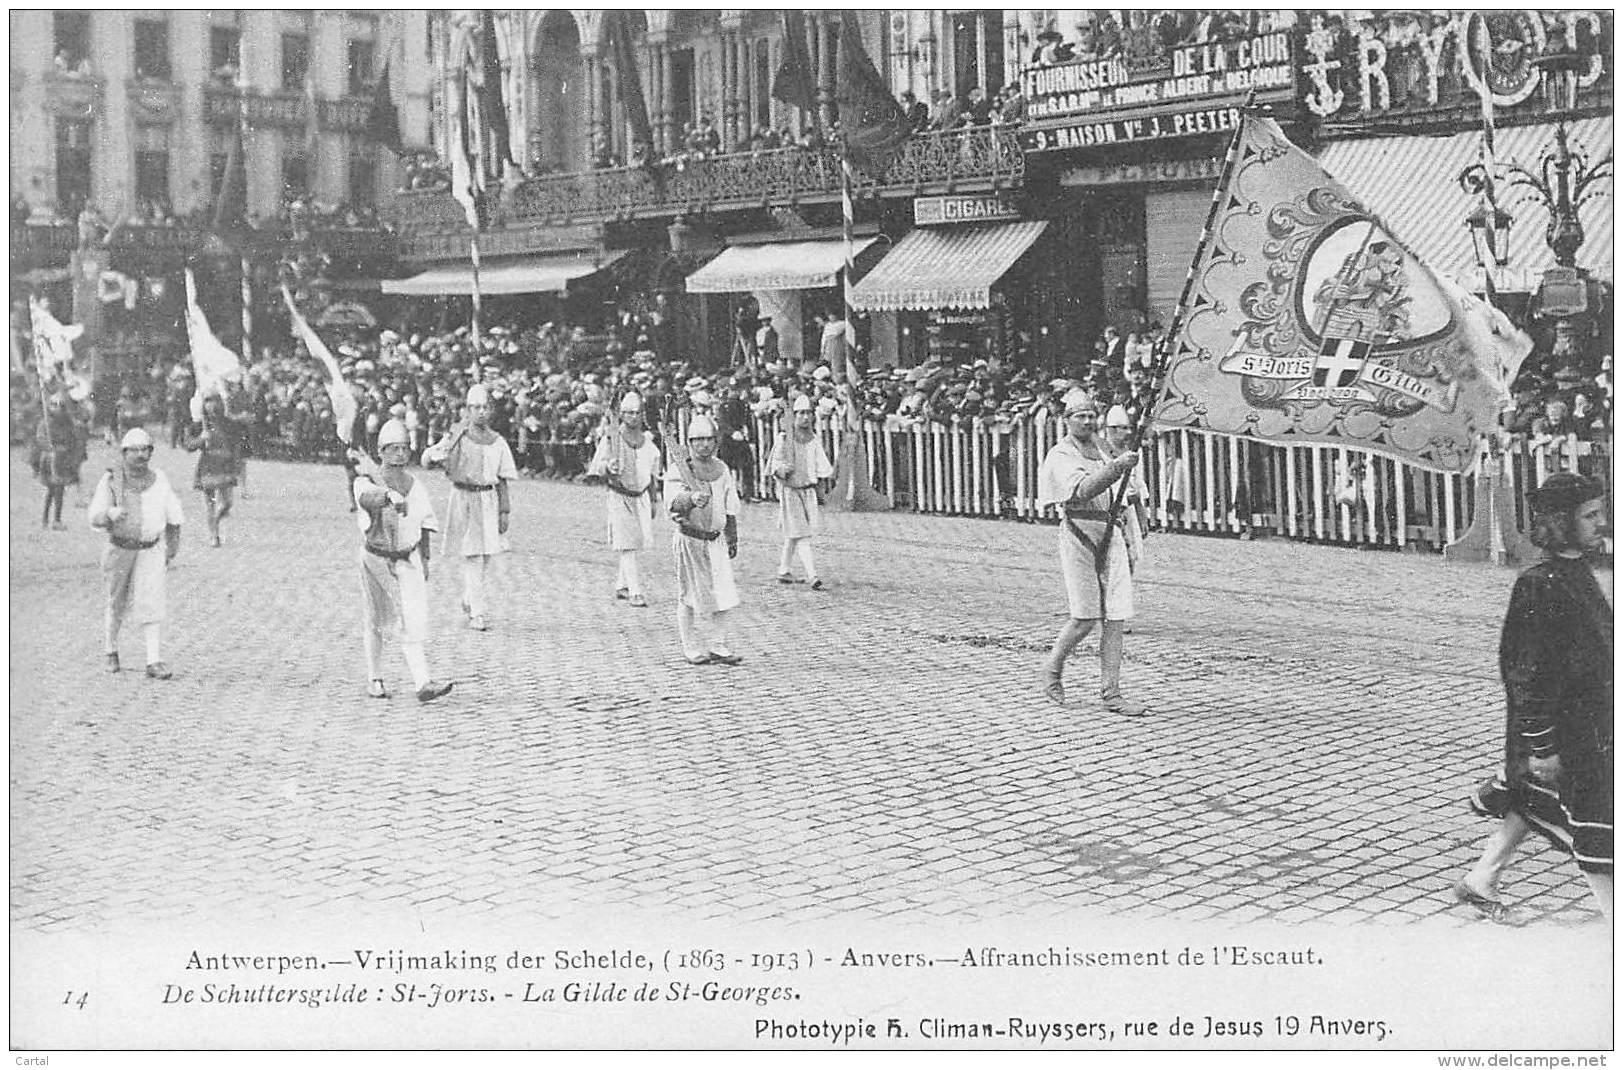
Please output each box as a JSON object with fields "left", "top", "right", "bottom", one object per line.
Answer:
{"left": 390, "top": 127, "right": 1026, "bottom": 258}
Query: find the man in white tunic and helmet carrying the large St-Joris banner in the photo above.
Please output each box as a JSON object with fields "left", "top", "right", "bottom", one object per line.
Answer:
{"left": 1037, "top": 390, "right": 1144, "bottom": 716}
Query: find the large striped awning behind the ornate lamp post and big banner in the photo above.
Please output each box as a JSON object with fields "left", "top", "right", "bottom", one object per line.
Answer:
{"left": 1319, "top": 119, "right": 1613, "bottom": 291}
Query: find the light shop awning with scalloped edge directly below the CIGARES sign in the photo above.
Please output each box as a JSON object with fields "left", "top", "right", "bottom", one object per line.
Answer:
{"left": 850, "top": 221, "right": 1048, "bottom": 312}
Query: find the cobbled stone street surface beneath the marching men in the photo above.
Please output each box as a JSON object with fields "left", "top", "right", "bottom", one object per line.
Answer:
{"left": 10, "top": 448, "right": 1599, "bottom": 934}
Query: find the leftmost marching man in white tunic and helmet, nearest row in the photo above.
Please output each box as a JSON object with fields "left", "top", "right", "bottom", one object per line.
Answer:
{"left": 89, "top": 427, "right": 182, "bottom": 680}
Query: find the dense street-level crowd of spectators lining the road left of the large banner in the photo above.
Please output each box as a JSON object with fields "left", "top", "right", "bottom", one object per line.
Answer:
{"left": 101, "top": 305, "right": 1175, "bottom": 479}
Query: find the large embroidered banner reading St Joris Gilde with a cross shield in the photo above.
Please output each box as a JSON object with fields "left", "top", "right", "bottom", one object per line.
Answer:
{"left": 1154, "top": 115, "right": 1532, "bottom": 472}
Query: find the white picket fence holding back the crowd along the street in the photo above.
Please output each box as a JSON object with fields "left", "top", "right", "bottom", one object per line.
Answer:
{"left": 727, "top": 412, "right": 1612, "bottom": 552}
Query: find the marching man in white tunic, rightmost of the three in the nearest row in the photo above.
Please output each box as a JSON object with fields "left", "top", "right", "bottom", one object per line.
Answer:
{"left": 665, "top": 416, "right": 743, "bottom": 666}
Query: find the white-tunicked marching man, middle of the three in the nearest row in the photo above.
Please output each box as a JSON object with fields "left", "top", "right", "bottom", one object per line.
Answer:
{"left": 351, "top": 421, "right": 451, "bottom": 701}
